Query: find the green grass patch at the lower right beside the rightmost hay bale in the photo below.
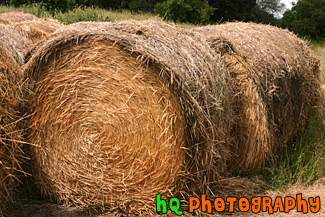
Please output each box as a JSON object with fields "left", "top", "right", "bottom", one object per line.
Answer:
{"left": 262, "top": 111, "right": 325, "bottom": 189}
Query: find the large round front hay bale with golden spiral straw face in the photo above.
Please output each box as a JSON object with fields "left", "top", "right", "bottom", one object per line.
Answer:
{"left": 24, "top": 21, "right": 232, "bottom": 212}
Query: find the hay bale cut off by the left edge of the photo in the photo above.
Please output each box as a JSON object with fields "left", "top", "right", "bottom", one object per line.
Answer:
{"left": 0, "top": 24, "right": 27, "bottom": 215}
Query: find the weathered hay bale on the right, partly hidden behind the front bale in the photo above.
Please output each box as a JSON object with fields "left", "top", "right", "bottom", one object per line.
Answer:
{"left": 193, "top": 22, "right": 320, "bottom": 170}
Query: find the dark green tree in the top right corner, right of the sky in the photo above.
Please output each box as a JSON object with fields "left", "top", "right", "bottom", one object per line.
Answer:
{"left": 280, "top": 0, "right": 325, "bottom": 40}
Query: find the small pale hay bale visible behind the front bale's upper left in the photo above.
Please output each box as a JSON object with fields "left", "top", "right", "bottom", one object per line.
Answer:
{"left": 13, "top": 18, "right": 64, "bottom": 43}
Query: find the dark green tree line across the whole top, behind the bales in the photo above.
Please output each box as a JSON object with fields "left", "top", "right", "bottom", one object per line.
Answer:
{"left": 0, "top": 0, "right": 325, "bottom": 40}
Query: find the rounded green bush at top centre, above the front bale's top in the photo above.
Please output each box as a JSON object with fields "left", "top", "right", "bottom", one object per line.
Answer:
{"left": 154, "top": 0, "right": 215, "bottom": 24}
